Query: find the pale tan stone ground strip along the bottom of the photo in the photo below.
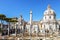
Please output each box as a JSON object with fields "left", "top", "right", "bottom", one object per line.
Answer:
{"left": 0, "top": 34, "right": 60, "bottom": 40}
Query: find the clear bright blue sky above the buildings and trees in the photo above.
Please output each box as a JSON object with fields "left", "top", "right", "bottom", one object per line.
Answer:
{"left": 0, "top": 0, "right": 60, "bottom": 21}
